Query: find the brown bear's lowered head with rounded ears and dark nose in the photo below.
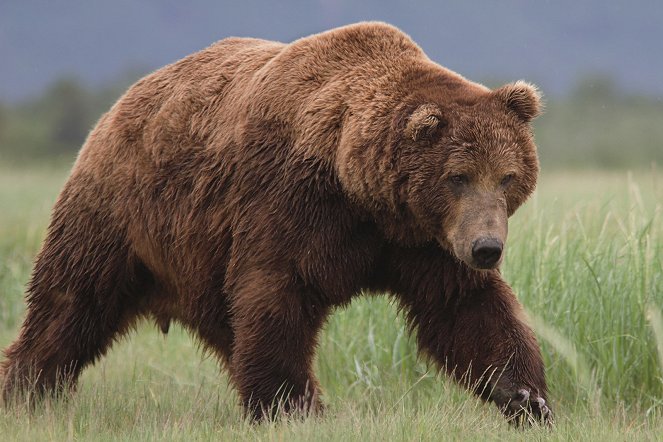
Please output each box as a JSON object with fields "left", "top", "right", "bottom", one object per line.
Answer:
{"left": 339, "top": 79, "right": 541, "bottom": 269}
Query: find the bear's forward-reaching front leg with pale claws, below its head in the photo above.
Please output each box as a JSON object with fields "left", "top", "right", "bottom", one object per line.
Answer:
{"left": 394, "top": 272, "right": 552, "bottom": 423}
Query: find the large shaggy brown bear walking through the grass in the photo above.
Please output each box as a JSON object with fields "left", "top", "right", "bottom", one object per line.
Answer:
{"left": 1, "top": 23, "right": 551, "bottom": 420}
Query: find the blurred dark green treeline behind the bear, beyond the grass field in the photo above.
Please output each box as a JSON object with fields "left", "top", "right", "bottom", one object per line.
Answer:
{"left": 0, "top": 72, "right": 663, "bottom": 168}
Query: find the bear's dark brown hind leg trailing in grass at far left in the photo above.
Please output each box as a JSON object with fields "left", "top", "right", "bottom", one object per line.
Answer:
{"left": 0, "top": 238, "right": 149, "bottom": 403}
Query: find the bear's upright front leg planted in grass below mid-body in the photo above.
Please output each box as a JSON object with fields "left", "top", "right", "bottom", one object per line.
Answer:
{"left": 231, "top": 271, "right": 327, "bottom": 420}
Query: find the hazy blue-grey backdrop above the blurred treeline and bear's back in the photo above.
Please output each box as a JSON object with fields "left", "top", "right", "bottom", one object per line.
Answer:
{"left": 0, "top": 0, "right": 663, "bottom": 101}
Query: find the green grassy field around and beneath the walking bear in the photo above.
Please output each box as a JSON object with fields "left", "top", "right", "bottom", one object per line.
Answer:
{"left": 0, "top": 167, "right": 663, "bottom": 441}
